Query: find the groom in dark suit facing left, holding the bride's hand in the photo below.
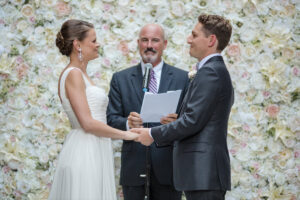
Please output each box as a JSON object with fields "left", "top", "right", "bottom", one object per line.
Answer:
{"left": 133, "top": 15, "right": 234, "bottom": 200}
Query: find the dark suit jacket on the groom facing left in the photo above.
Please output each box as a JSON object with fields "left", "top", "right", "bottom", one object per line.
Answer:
{"left": 151, "top": 56, "right": 234, "bottom": 191}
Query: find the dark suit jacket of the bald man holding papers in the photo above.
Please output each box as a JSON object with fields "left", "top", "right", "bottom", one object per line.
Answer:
{"left": 107, "top": 63, "right": 189, "bottom": 186}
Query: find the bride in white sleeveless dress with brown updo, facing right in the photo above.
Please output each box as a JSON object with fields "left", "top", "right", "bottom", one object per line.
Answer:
{"left": 49, "top": 20, "right": 137, "bottom": 200}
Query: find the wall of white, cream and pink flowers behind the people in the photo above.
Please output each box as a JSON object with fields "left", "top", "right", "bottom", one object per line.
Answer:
{"left": 0, "top": 0, "right": 300, "bottom": 200}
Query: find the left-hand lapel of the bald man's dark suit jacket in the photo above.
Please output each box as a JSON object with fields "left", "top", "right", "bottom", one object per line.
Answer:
{"left": 131, "top": 64, "right": 144, "bottom": 102}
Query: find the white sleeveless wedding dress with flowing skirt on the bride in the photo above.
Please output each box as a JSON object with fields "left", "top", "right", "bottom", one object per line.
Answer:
{"left": 49, "top": 67, "right": 116, "bottom": 200}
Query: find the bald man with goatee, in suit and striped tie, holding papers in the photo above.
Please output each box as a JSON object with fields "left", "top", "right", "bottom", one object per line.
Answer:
{"left": 107, "top": 24, "right": 189, "bottom": 200}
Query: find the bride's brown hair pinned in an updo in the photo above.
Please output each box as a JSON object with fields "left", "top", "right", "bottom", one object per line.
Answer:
{"left": 56, "top": 19, "right": 94, "bottom": 56}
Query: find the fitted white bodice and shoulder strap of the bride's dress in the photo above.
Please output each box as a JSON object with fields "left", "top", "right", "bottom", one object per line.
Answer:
{"left": 59, "top": 67, "right": 108, "bottom": 129}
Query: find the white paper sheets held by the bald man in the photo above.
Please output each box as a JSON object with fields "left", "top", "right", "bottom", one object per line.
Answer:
{"left": 140, "top": 90, "right": 181, "bottom": 123}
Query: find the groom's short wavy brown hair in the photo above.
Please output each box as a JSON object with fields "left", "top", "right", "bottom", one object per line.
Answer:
{"left": 198, "top": 14, "right": 232, "bottom": 51}
